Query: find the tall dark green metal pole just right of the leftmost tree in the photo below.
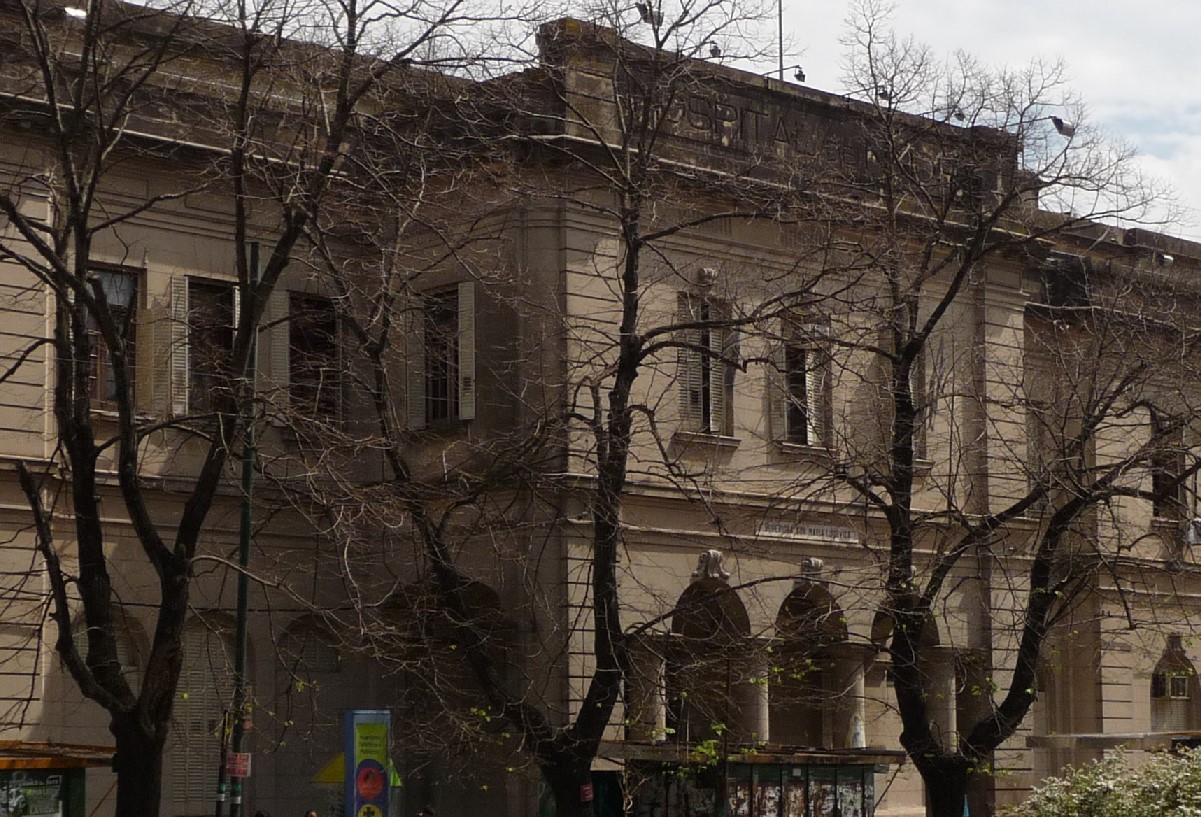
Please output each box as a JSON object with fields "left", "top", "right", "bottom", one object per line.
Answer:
{"left": 229, "top": 241, "right": 258, "bottom": 817}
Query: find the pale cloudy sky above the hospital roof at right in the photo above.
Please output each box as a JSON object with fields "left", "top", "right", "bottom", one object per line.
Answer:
{"left": 783, "top": 0, "right": 1201, "bottom": 240}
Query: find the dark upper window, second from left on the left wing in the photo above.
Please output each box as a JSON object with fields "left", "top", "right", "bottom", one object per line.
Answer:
{"left": 187, "top": 279, "right": 238, "bottom": 413}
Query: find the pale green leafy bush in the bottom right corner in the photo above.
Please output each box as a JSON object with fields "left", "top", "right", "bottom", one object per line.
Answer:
{"left": 1006, "top": 750, "right": 1201, "bottom": 817}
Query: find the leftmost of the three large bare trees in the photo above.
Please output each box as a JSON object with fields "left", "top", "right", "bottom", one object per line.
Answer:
{"left": 0, "top": 0, "right": 495, "bottom": 815}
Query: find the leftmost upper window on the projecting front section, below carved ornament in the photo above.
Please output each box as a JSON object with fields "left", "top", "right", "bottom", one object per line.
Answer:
{"left": 677, "top": 294, "right": 737, "bottom": 436}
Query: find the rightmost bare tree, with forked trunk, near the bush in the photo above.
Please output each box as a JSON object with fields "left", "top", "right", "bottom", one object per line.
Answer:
{"left": 779, "top": 4, "right": 1201, "bottom": 817}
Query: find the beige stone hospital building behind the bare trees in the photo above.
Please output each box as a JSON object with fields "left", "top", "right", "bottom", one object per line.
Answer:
{"left": 0, "top": 6, "right": 1201, "bottom": 817}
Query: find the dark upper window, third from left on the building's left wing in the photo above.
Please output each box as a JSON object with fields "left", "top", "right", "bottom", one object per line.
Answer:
{"left": 287, "top": 293, "right": 341, "bottom": 418}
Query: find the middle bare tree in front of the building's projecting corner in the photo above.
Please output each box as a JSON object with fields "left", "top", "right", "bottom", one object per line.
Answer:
{"left": 276, "top": 2, "right": 850, "bottom": 815}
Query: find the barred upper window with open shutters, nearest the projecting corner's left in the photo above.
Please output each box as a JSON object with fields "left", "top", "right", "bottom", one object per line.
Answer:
{"left": 407, "top": 281, "right": 476, "bottom": 429}
